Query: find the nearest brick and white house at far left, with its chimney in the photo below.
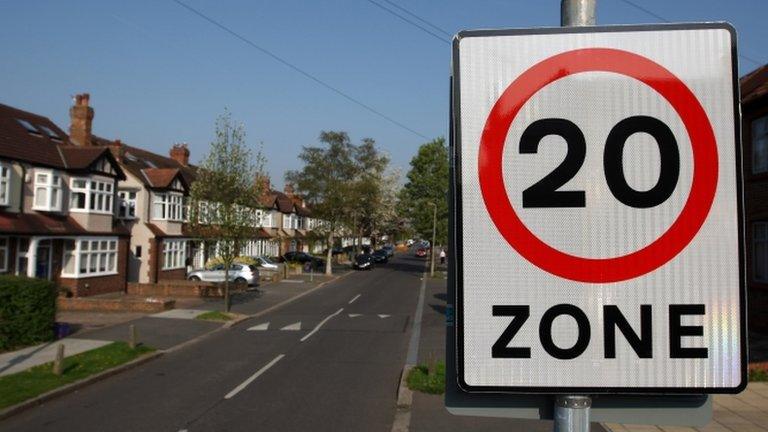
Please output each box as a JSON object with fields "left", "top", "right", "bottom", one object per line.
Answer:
{"left": 0, "top": 100, "right": 130, "bottom": 296}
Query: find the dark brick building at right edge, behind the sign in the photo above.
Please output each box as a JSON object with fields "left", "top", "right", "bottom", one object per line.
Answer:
{"left": 740, "top": 65, "right": 768, "bottom": 331}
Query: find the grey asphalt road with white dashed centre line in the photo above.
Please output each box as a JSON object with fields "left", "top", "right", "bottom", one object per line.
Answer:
{"left": 0, "top": 257, "right": 424, "bottom": 432}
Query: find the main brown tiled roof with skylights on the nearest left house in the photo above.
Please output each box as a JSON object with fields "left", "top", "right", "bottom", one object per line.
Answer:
{"left": 0, "top": 104, "right": 124, "bottom": 178}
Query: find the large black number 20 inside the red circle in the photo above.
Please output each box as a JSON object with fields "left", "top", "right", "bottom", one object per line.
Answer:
{"left": 520, "top": 116, "right": 680, "bottom": 208}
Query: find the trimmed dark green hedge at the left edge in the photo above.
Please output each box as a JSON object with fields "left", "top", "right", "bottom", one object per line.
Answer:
{"left": 0, "top": 275, "right": 58, "bottom": 351}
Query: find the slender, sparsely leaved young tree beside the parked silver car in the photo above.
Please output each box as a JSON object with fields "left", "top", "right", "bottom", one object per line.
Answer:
{"left": 189, "top": 111, "right": 266, "bottom": 312}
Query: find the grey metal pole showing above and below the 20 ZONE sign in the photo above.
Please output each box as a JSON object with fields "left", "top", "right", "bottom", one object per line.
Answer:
{"left": 554, "top": 0, "right": 597, "bottom": 432}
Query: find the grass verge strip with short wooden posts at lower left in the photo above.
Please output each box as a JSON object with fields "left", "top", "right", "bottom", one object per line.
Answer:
{"left": 0, "top": 342, "right": 154, "bottom": 409}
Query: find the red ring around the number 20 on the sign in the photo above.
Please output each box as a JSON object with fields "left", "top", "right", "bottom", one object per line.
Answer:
{"left": 478, "top": 48, "right": 718, "bottom": 283}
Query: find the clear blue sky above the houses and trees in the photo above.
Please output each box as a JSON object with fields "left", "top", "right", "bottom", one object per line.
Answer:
{"left": 0, "top": 0, "right": 768, "bottom": 188}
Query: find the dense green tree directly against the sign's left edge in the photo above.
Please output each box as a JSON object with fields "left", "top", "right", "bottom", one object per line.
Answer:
{"left": 399, "top": 137, "right": 448, "bottom": 244}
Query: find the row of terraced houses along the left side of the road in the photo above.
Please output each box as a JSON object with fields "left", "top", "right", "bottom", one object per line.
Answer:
{"left": 0, "top": 94, "right": 322, "bottom": 296}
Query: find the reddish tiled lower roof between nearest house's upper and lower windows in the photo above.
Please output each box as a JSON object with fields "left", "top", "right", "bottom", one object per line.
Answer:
{"left": 0, "top": 212, "right": 130, "bottom": 236}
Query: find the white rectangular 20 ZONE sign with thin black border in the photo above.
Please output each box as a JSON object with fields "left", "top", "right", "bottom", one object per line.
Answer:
{"left": 453, "top": 24, "right": 746, "bottom": 393}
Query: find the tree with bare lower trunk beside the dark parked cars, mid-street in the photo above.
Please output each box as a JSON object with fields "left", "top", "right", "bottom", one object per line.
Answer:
{"left": 285, "top": 131, "right": 357, "bottom": 275}
